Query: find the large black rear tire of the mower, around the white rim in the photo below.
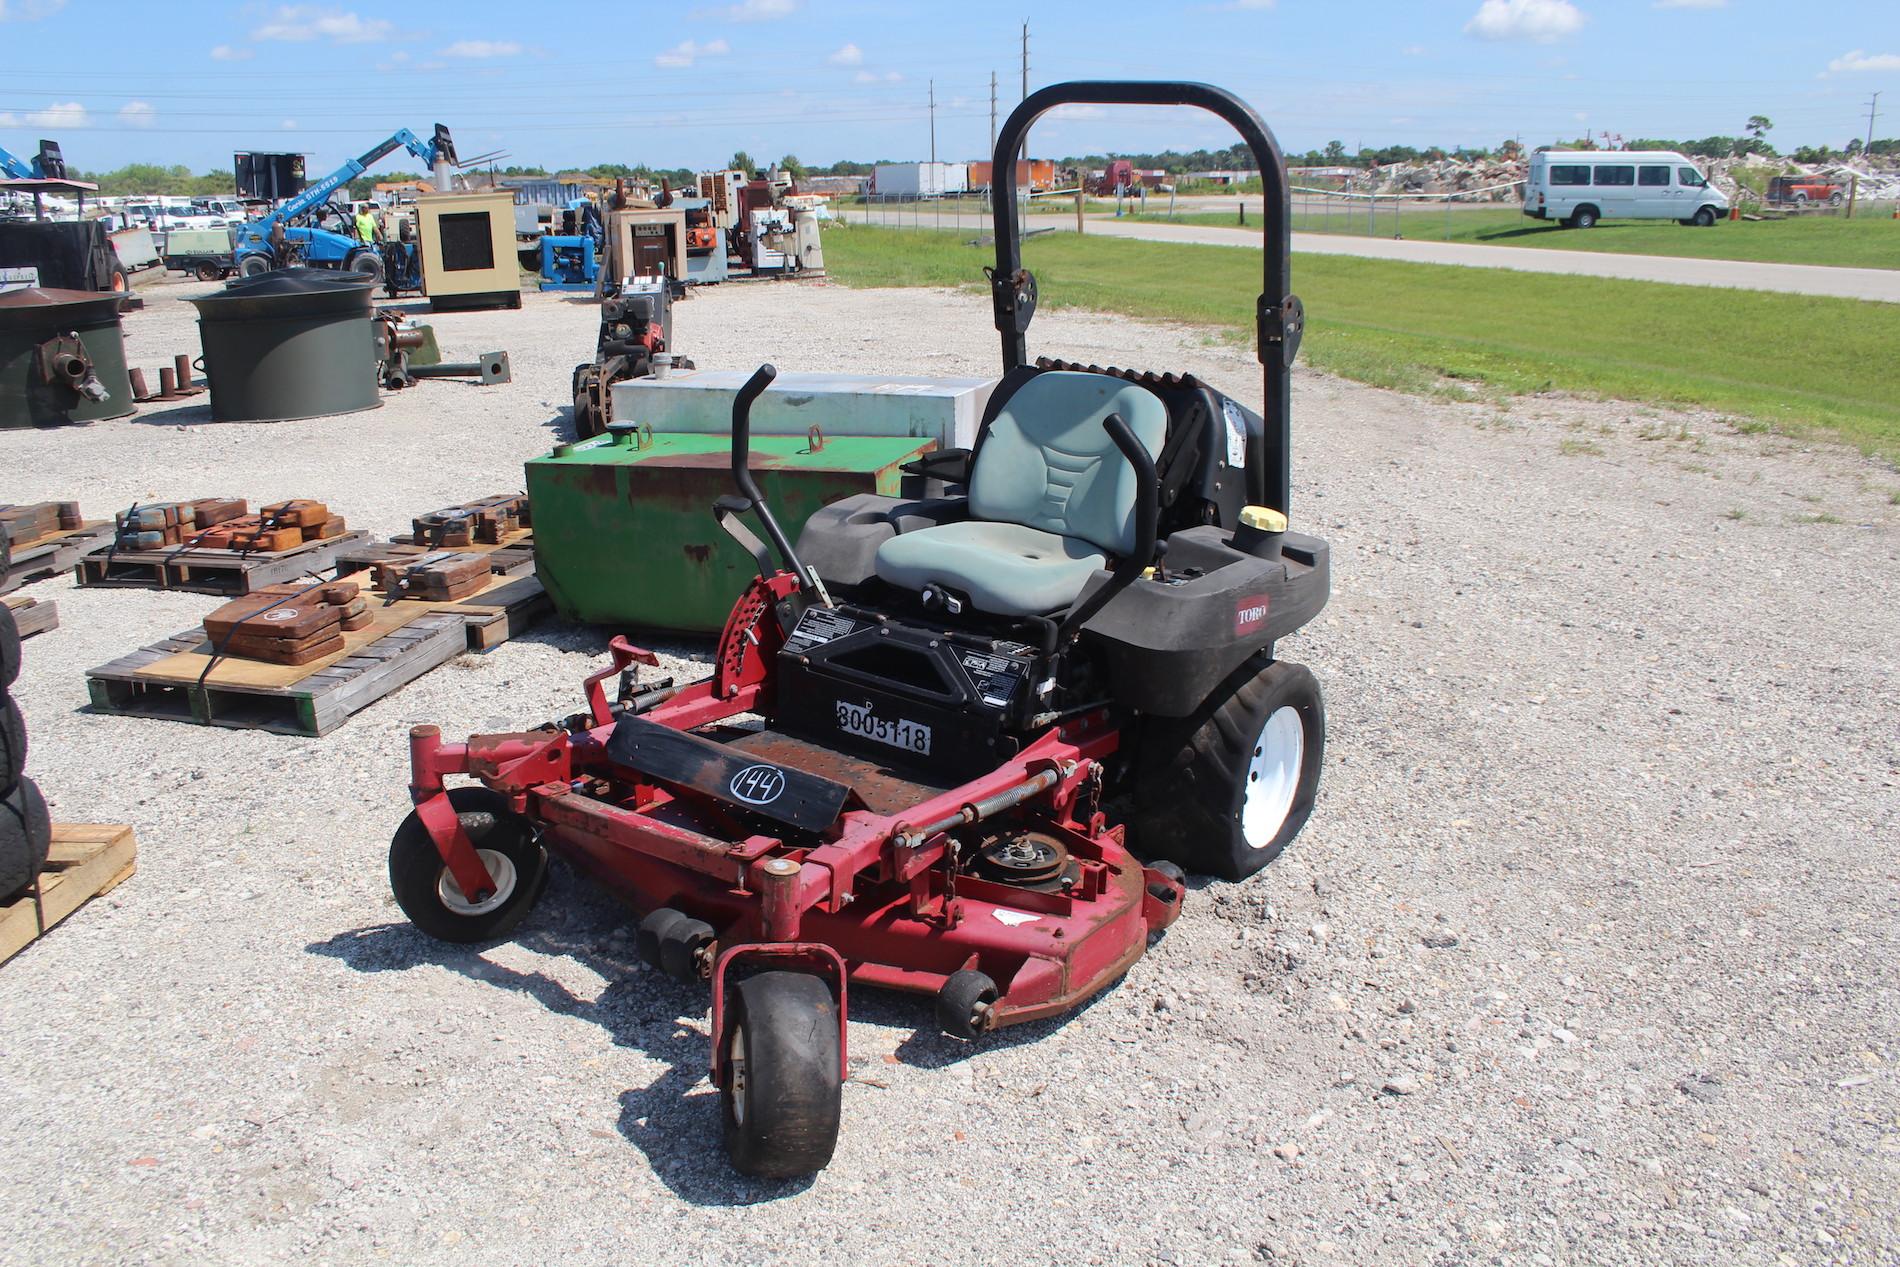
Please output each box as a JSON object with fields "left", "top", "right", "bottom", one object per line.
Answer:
{"left": 1129, "top": 655, "right": 1326, "bottom": 879}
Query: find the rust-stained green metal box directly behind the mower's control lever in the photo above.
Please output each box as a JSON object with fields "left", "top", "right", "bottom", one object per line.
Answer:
{"left": 526, "top": 429, "right": 937, "bottom": 634}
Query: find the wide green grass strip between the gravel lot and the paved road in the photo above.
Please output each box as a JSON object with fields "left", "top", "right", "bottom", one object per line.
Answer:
{"left": 825, "top": 226, "right": 1900, "bottom": 458}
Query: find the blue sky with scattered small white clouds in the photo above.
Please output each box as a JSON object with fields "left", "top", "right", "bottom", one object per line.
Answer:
{"left": 0, "top": 0, "right": 1900, "bottom": 173}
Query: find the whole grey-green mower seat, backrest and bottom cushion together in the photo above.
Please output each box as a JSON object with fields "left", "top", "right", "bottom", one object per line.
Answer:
{"left": 876, "top": 370, "right": 1169, "bottom": 615}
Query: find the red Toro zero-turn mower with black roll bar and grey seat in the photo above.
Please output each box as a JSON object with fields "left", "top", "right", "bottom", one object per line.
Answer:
{"left": 390, "top": 84, "right": 1328, "bottom": 1176}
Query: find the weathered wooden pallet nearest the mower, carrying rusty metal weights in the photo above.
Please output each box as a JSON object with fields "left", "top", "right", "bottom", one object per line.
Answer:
{"left": 86, "top": 577, "right": 551, "bottom": 735}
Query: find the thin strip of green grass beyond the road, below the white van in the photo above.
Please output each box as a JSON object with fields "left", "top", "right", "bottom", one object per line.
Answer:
{"left": 1134, "top": 201, "right": 1900, "bottom": 268}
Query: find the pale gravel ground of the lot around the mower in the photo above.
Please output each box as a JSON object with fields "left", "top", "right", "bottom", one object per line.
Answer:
{"left": 0, "top": 275, "right": 1900, "bottom": 1263}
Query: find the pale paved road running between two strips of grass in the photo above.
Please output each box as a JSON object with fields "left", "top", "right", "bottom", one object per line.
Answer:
{"left": 847, "top": 207, "right": 1900, "bottom": 304}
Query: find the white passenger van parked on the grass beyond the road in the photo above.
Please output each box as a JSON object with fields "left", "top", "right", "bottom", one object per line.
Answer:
{"left": 1524, "top": 150, "right": 1729, "bottom": 228}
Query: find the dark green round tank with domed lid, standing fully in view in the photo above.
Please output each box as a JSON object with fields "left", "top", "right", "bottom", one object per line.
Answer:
{"left": 192, "top": 268, "right": 382, "bottom": 422}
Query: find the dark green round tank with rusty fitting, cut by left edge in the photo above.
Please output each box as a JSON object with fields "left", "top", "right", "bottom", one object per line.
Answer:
{"left": 0, "top": 287, "right": 133, "bottom": 427}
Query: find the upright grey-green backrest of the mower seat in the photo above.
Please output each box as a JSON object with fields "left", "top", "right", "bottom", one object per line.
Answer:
{"left": 969, "top": 370, "right": 1169, "bottom": 555}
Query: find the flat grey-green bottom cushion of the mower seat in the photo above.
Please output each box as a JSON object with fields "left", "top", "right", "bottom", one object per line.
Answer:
{"left": 878, "top": 519, "right": 1108, "bottom": 615}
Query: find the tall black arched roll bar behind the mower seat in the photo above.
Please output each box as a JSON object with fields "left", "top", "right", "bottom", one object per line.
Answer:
{"left": 990, "top": 80, "right": 1305, "bottom": 515}
